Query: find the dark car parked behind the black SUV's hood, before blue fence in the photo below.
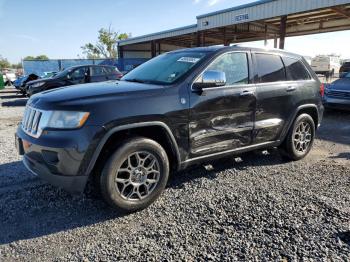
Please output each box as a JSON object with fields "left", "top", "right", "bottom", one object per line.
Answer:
{"left": 25, "top": 65, "right": 123, "bottom": 96}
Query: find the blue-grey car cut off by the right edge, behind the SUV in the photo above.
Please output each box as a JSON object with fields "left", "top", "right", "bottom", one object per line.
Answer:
{"left": 323, "top": 72, "right": 350, "bottom": 110}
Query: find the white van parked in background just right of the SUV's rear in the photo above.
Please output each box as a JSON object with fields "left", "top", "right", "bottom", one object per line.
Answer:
{"left": 311, "top": 55, "right": 340, "bottom": 78}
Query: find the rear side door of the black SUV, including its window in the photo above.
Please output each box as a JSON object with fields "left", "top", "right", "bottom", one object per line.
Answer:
{"left": 253, "top": 52, "right": 299, "bottom": 144}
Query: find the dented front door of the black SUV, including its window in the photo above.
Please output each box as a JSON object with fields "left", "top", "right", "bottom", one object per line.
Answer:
{"left": 189, "top": 52, "right": 256, "bottom": 158}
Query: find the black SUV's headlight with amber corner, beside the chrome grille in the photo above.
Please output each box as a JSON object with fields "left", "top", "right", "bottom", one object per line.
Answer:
{"left": 47, "top": 111, "right": 90, "bottom": 129}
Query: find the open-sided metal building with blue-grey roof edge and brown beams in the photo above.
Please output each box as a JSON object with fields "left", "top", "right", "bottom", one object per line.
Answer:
{"left": 119, "top": 0, "right": 350, "bottom": 58}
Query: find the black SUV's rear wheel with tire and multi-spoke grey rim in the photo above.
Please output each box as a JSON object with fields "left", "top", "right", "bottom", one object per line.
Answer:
{"left": 280, "top": 114, "right": 315, "bottom": 161}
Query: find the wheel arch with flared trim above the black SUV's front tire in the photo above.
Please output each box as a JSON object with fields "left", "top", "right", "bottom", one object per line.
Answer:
{"left": 85, "top": 121, "right": 181, "bottom": 175}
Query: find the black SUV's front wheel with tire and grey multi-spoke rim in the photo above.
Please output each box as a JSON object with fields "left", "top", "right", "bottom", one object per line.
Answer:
{"left": 100, "top": 137, "right": 169, "bottom": 212}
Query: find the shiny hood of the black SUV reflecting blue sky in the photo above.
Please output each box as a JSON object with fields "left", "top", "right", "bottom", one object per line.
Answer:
{"left": 28, "top": 80, "right": 163, "bottom": 109}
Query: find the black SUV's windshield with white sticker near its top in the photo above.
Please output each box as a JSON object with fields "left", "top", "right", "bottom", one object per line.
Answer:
{"left": 121, "top": 51, "right": 208, "bottom": 84}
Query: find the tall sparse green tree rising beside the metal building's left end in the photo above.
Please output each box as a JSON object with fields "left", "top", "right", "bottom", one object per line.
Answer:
{"left": 81, "top": 26, "right": 131, "bottom": 59}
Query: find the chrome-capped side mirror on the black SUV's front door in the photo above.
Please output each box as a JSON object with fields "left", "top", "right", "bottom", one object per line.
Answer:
{"left": 193, "top": 70, "right": 226, "bottom": 90}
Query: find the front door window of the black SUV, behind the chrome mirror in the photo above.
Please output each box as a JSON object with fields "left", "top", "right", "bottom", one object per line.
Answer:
{"left": 207, "top": 53, "right": 249, "bottom": 86}
